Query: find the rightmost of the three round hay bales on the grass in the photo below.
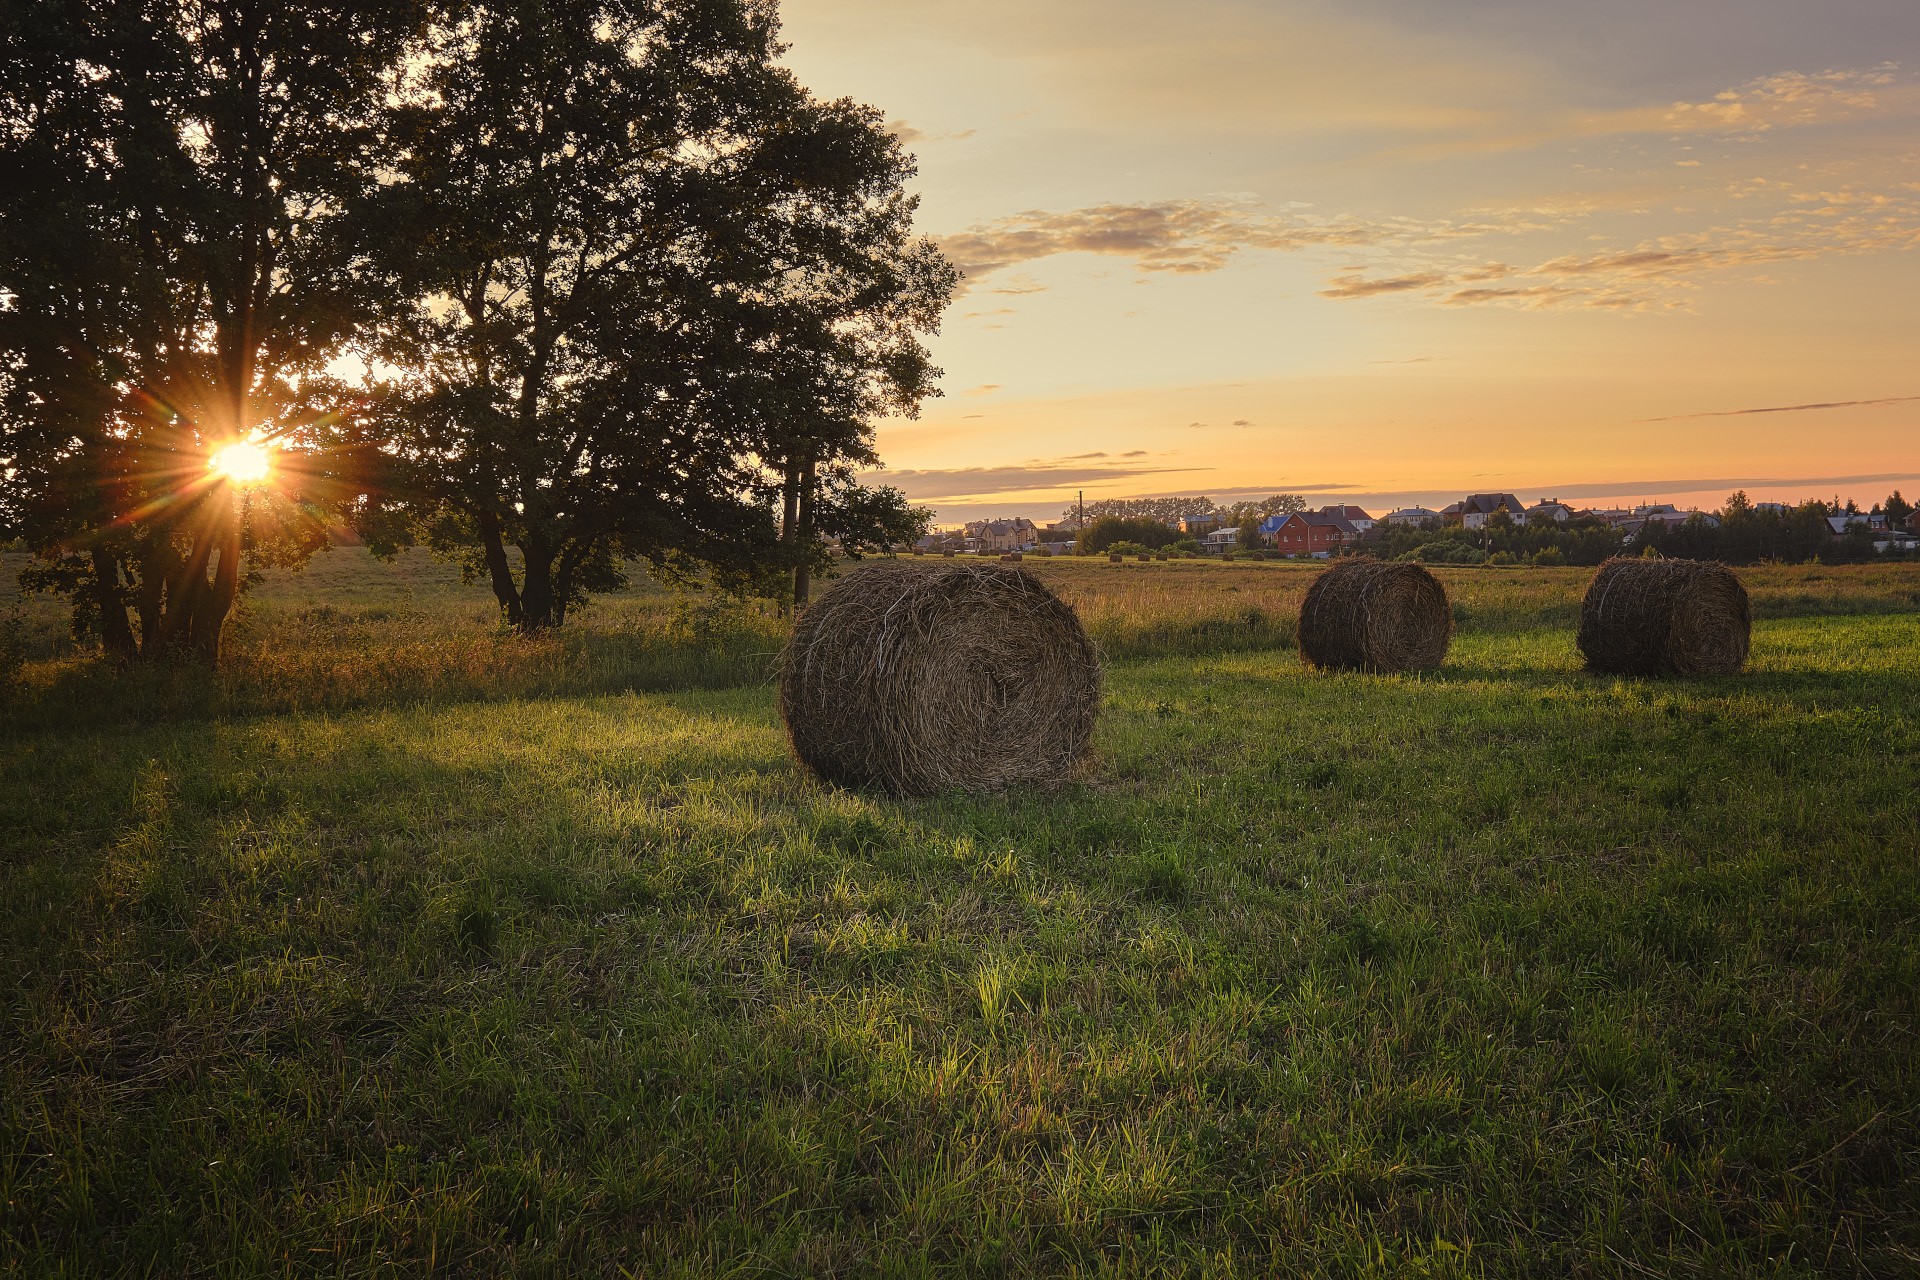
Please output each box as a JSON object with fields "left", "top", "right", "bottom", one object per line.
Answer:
{"left": 1578, "top": 557, "right": 1753, "bottom": 676}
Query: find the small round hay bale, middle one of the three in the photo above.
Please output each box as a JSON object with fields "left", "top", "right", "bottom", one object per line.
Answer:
{"left": 1300, "top": 560, "right": 1453, "bottom": 672}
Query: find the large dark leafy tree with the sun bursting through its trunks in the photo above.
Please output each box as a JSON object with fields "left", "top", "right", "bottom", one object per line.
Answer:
{"left": 0, "top": 0, "right": 419, "bottom": 658}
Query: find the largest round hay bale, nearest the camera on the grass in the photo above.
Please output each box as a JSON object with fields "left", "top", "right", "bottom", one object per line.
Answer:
{"left": 780, "top": 560, "right": 1100, "bottom": 796}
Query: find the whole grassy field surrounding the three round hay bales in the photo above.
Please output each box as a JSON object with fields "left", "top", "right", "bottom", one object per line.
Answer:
{"left": 0, "top": 549, "right": 1920, "bottom": 1276}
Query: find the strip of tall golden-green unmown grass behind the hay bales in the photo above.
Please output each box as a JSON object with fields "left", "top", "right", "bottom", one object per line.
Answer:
{"left": 0, "top": 547, "right": 1920, "bottom": 727}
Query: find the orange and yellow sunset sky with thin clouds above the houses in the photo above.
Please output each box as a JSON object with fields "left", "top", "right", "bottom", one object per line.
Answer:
{"left": 781, "top": 0, "right": 1920, "bottom": 524}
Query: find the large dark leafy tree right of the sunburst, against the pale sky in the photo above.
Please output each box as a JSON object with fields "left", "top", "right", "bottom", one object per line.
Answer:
{"left": 367, "top": 0, "right": 952, "bottom": 629}
